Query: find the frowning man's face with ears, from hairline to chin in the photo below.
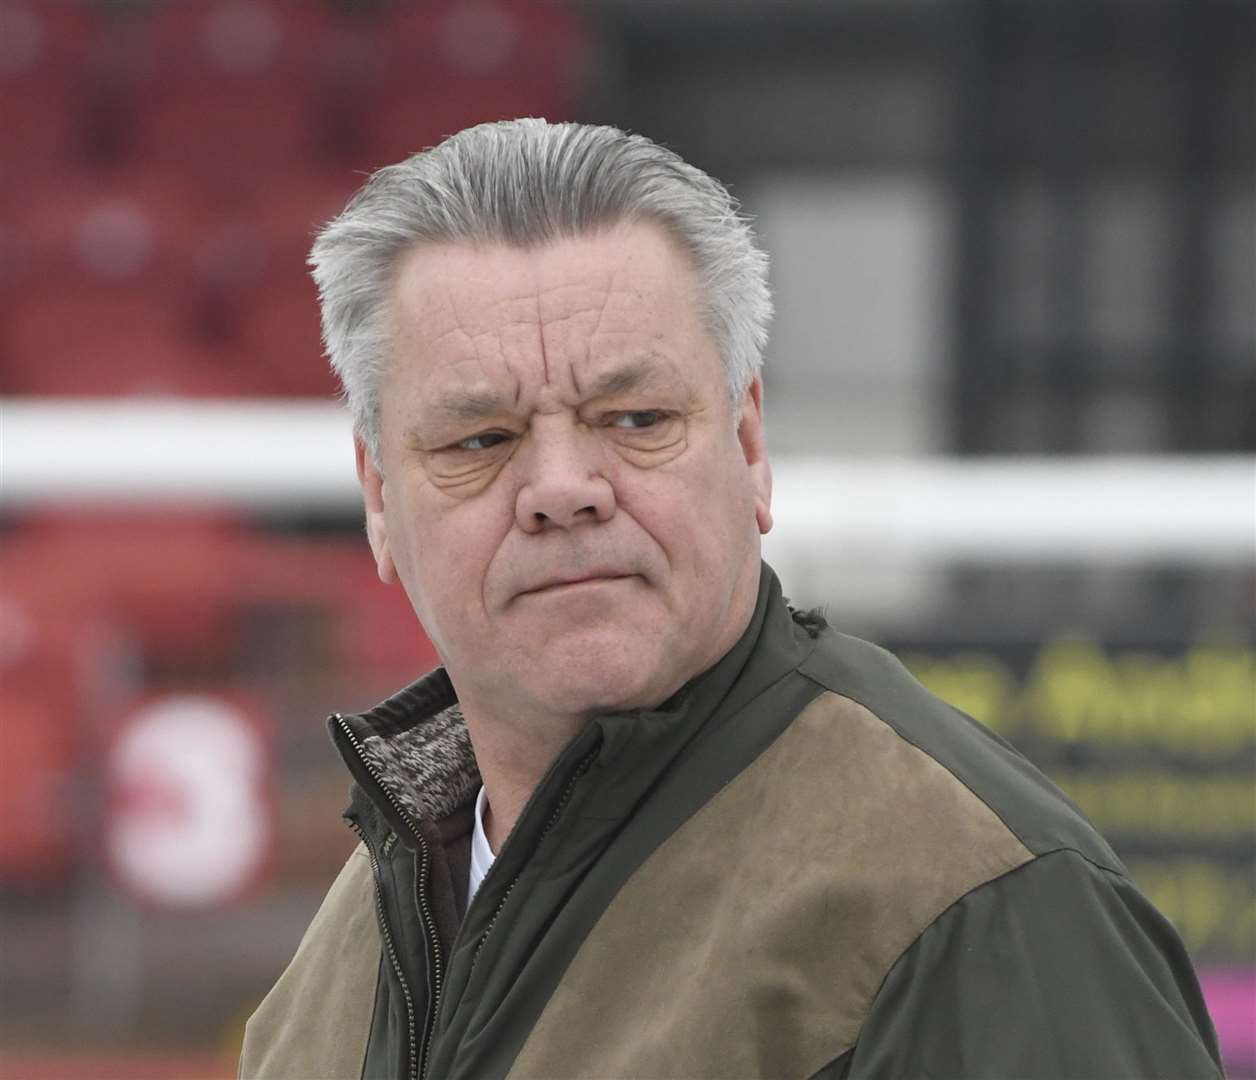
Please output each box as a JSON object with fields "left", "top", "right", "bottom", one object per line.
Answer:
{"left": 358, "top": 224, "right": 770, "bottom": 716}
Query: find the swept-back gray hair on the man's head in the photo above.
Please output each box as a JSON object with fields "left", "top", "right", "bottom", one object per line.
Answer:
{"left": 310, "top": 119, "right": 772, "bottom": 462}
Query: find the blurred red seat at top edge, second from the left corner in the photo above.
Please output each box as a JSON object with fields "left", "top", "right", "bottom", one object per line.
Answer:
{"left": 123, "top": 0, "right": 344, "bottom": 190}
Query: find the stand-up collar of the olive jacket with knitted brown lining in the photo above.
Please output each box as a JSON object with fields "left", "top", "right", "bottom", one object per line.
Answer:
{"left": 328, "top": 563, "right": 823, "bottom": 836}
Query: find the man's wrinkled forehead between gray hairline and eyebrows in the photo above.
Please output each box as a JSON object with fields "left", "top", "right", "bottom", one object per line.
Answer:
{"left": 381, "top": 222, "right": 713, "bottom": 401}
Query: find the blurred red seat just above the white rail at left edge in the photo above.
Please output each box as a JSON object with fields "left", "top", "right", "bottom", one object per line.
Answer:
{"left": 0, "top": 170, "right": 237, "bottom": 394}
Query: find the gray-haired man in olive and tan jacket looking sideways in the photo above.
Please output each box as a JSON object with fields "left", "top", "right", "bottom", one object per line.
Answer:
{"left": 241, "top": 121, "right": 1220, "bottom": 1080}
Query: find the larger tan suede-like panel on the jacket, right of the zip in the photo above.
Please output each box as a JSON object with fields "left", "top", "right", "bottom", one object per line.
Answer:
{"left": 510, "top": 693, "right": 1032, "bottom": 1080}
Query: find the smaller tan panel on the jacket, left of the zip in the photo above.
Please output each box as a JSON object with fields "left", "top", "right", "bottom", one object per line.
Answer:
{"left": 240, "top": 844, "right": 379, "bottom": 1080}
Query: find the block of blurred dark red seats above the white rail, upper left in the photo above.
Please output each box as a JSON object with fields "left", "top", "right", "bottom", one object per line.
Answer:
{"left": 0, "top": 0, "right": 584, "bottom": 397}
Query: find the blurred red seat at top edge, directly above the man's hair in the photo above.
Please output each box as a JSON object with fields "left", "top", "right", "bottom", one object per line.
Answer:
{"left": 363, "top": 0, "right": 585, "bottom": 167}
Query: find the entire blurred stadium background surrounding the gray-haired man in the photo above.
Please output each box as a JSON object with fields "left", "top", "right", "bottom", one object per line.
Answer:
{"left": 0, "top": 0, "right": 1256, "bottom": 1080}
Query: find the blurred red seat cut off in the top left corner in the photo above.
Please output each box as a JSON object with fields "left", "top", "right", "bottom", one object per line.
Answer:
{"left": 0, "top": 0, "right": 100, "bottom": 183}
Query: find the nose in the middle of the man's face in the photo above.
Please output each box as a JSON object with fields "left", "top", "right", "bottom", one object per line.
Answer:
{"left": 515, "top": 417, "right": 615, "bottom": 532}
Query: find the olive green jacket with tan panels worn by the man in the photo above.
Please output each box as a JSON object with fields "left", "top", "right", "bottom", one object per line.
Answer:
{"left": 241, "top": 566, "right": 1221, "bottom": 1080}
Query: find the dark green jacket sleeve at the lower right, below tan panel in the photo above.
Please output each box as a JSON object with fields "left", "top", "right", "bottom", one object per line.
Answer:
{"left": 844, "top": 850, "right": 1222, "bottom": 1080}
